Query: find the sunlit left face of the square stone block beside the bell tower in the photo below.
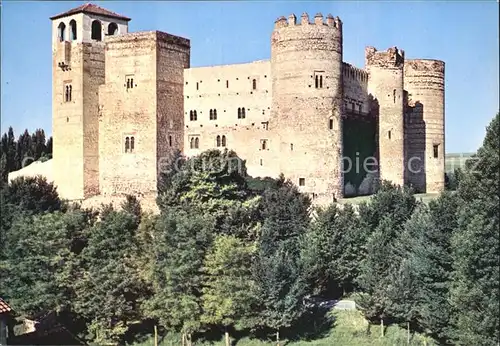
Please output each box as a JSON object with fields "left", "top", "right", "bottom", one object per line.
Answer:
{"left": 99, "top": 32, "right": 157, "bottom": 195}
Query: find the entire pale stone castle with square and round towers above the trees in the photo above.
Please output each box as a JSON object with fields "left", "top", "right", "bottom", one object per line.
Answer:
{"left": 20, "top": 4, "right": 445, "bottom": 203}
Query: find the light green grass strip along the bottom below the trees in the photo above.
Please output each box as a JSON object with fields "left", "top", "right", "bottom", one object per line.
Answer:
{"left": 133, "top": 310, "right": 436, "bottom": 346}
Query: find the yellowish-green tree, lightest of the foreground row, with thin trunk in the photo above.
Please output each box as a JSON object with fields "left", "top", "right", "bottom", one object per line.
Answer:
{"left": 202, "top": 235, "right": 256, "bottom": 346}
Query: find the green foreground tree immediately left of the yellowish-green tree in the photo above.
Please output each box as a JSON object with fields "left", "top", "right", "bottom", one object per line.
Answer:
{"left": 144, "top": 210, "right": 214, "bottom": 343}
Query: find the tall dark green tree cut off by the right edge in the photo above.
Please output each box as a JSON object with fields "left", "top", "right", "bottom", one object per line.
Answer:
{"left": 452, "top": 113, "right": 500, "bottom": 345}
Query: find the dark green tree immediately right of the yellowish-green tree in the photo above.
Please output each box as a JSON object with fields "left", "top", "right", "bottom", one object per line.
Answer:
{"left": 253, "top": 176, "right": 311, "bottom": 342}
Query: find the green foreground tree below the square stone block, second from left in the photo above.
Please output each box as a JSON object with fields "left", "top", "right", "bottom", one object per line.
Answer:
{"left": 74, "top": 211, "right": 144, "bottom": 343}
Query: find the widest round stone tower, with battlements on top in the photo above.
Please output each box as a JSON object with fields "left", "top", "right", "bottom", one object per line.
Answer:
{"left": 271, "top": 13, "right": 342, "bottom": 202}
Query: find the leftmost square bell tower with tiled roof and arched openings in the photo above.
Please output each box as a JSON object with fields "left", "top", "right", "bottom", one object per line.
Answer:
{"left": 50, "top": 4, "right": 130, "bottom": 200}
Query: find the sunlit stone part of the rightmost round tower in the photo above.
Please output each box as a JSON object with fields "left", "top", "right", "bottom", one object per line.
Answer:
{"left": 404, "top": 59, "right": 445, "bottom": 193}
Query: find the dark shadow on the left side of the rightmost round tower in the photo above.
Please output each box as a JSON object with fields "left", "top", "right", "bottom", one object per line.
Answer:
{"left": 405, "top": 101, "right": 426, "bottom": 193}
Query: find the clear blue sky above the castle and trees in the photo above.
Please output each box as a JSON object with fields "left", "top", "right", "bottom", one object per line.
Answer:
{"left": 1, "top": 1, "right": 499, "bottom": 152}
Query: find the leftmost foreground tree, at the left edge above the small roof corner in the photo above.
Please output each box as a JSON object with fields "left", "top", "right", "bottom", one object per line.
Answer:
{"left": 0, "top": 210, "right": 95, "bottom": 316}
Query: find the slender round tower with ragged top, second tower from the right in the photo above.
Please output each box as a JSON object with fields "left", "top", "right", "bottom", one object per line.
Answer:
{"left": 365, "top": 47, "right": 405, "bottom": 186}
